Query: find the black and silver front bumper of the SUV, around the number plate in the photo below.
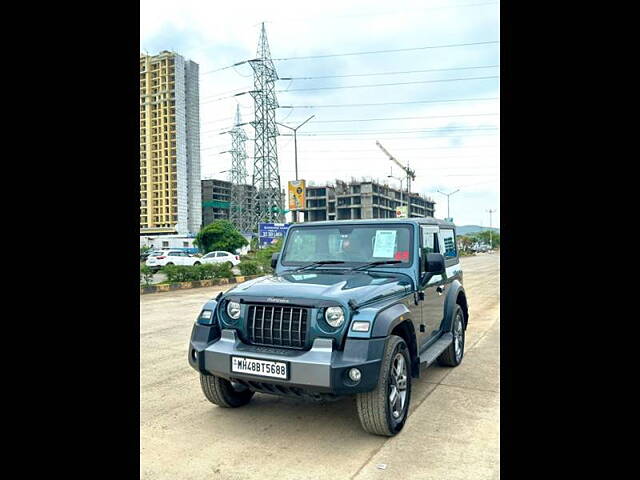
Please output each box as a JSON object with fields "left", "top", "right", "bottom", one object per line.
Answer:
{"left": 188, "top": 324, "right": 386, "bottom": 395}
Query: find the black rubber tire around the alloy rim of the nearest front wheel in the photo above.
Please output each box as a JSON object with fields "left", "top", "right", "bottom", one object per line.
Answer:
{"left": 356, "top": 335, "right": 411, "bottom": 437}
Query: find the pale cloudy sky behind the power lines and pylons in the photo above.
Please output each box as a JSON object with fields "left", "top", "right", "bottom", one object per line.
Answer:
{"left": 140, "top": 0, "right": 500, "bottom": 227}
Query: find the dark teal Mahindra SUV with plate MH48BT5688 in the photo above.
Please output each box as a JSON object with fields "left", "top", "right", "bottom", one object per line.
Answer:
{"left": 188, "top": 218, "right": 469, "bottom": 436}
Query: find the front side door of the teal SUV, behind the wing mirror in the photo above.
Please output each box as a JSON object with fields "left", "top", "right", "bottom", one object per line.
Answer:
{"left": 420, "top": 225, "right": 446, "bottom": 349}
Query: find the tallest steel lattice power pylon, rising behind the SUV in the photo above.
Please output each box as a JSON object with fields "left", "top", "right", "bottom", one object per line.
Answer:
{"left": 249, "top": 23, "right": 284, "bottom": 231}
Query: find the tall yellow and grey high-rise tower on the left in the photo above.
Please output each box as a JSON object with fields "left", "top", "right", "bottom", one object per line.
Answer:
{"left": 140, "top": 51, "right": 202, "bottom": 235}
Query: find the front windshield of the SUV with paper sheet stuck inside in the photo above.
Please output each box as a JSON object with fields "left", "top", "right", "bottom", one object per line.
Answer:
{"left": 282, "top": 225, "right": 412, "bottom": 268}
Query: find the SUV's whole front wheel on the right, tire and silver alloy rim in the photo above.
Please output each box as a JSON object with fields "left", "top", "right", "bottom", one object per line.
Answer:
{"left": 356, "top": 335, "right": 411, "bottom": 437}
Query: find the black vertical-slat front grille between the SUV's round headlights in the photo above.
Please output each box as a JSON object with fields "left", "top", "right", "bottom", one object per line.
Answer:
{"left": 247, "top": 305, "right": 309, "bottom": 349}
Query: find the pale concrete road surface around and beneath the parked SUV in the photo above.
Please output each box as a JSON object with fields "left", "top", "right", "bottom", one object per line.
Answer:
{"left": 140, "top": 254, "right": 500, "bottom": 480}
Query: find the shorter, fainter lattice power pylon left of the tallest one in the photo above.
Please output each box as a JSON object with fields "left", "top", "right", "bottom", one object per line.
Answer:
{"left": 229, "top": 105, "right": 253, "bottom": 232}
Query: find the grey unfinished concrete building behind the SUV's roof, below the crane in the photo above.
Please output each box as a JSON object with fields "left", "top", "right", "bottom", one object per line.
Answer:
{"left": 304, "top": 180, "right": 435, "bottom": 222}
